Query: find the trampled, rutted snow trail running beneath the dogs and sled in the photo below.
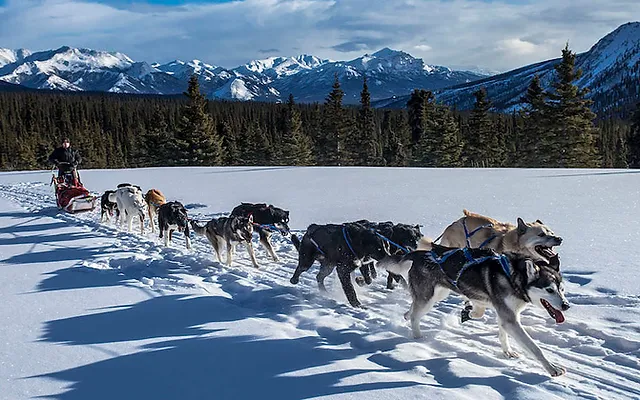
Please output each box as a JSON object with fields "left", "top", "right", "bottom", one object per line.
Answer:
{"left": 0, "top": 183, "right": 640, "bottom": 399}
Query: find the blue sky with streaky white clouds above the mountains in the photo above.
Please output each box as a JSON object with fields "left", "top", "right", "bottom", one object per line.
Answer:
{"left": 0, "top": 0, "right": 640, "bottom": 71}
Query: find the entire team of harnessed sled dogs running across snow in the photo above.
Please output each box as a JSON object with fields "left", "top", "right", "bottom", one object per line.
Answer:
{"left": 101, "top": 183, "right": 570, "bottom": 376}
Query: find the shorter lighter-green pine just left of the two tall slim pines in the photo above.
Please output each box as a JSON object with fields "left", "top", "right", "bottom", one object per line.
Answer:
{"left": 283, "top": 94, "right": 314, "bottom": 165}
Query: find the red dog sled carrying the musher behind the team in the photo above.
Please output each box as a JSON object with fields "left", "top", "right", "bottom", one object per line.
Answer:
{"left": 51, "top": 162, "right": 97, "bottom": 213}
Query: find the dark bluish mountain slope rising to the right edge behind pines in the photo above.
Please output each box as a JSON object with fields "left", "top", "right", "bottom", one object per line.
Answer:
{"left": 376, "top": 22, "right": 640, "bottom": 112}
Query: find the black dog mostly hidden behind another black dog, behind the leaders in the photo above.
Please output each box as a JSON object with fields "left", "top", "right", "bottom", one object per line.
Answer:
{"left": 356, "top": 219, "right": 422, "bottom": 289}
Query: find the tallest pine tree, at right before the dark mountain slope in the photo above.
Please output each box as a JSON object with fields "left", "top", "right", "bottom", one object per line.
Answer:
{"left": 547, "top": 44, "right": 599, "bottom": 168}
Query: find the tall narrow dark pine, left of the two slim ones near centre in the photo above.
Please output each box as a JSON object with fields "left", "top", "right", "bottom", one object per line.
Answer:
{"left": 322, "top": 74, "right": 350, "bottom": 165}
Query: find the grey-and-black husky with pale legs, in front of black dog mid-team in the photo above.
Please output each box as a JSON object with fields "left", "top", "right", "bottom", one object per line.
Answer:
{"left": 191, "top": 215, "right": 259, "bottom": 268}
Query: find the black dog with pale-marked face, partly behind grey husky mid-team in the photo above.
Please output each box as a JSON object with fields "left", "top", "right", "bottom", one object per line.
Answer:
{"left": 231, "top": 203, "right": 289, "bottom": 261}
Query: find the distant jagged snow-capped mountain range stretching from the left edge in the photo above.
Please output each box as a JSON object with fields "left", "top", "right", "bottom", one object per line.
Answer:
{"left": 0, "top": 46, "right": 484, "bottom": 103}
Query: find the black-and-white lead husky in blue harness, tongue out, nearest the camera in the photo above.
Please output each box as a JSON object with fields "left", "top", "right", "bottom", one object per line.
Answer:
{"left": 380, "top": 244, "right": 569, "bottom": 376}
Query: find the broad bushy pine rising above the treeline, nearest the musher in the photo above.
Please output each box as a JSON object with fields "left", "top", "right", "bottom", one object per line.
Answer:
{"left": 176, "top": 74, "right": 223, "bottom": 165}
